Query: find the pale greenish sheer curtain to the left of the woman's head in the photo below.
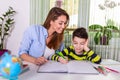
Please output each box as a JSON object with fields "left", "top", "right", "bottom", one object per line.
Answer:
{"left": 30, "top": 0, "right": 50, "bottom": 24}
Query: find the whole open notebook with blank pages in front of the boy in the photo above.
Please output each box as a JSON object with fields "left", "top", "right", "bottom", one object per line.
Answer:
{"left": 37, "top": 61, "right": 98, "bottom": 74}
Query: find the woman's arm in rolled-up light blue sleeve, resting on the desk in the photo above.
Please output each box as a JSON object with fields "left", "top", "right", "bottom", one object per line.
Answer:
{"left": 18, "top": 25, "right": 47, "bottom": 64}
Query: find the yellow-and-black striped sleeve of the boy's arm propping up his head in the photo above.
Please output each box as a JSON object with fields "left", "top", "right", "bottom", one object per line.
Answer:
{"left": 87, "top": 50, "right": 101, "bottom": 64}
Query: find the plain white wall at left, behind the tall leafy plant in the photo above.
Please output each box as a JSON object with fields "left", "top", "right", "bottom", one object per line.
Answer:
{"left": 0, "top": 0, "right": 30, "bottom": 55}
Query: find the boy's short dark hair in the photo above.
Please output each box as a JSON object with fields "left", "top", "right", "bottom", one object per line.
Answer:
{"left": 72, "top": 27, "right": 88, "bottom": 39}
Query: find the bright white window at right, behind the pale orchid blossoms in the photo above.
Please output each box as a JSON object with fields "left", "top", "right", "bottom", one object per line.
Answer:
{"left": 89, "top": 0, "right": 120, "bottom": 28}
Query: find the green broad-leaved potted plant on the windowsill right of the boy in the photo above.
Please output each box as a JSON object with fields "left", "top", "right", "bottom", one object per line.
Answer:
{"left": 89, "top": 24, "right": 118, "bottom": 45}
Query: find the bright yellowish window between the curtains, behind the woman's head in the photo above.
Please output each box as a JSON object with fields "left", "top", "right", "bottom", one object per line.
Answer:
{"left": 50, "top": 0, "right": 79, "bottom": 47}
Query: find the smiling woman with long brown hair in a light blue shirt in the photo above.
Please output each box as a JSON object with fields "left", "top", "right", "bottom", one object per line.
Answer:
{"left": 19, "top": 7, "right": 69, "bottom": 65}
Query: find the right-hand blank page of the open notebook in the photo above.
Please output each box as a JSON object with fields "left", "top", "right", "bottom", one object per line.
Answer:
{"left": 67, "top": 61, "right": 99, "bottom": 74}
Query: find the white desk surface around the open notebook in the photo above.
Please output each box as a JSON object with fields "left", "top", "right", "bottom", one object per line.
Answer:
{"left": 0, "top": 59, "right": 120, "bottom": 80}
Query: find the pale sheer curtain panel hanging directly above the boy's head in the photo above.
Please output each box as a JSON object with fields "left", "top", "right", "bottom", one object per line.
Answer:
{"left": 78, "top": 0, "right": 90, "bottom": 29}
